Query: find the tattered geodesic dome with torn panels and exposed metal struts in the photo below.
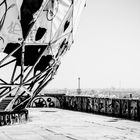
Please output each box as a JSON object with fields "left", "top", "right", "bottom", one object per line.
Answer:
{"left": 0, "top": 0, "right": 86, "bottom": 111}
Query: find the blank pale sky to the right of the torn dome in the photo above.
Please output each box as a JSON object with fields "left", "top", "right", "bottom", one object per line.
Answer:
{"left": 46, "top": 0, "right": 140, "bottom": 88}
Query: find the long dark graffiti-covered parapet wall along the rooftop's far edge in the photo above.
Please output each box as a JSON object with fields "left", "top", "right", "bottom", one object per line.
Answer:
{"left": 61, "top": 96, "right": 140, "bottom": 121}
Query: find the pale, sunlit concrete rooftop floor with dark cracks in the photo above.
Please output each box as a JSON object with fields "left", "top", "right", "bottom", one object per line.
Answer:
{"left": 0, "top": 108, "right": 140, "bottom": 140}
